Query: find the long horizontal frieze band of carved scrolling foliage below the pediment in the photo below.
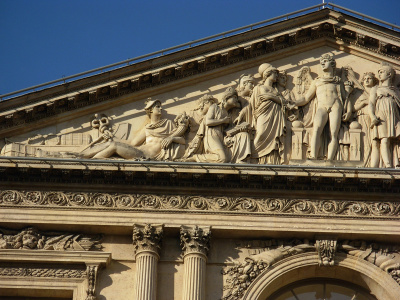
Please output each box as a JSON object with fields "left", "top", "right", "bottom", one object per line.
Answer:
{"left": 0, "top": 190, "right": 400, "bottom": 218}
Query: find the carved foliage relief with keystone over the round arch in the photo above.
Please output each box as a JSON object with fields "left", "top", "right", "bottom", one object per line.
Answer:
{"left": 222, "top": 239, "right": 400, "bottom": 300}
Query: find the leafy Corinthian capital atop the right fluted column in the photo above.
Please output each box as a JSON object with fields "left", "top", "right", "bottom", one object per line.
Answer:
{"left": 181, "top": 225, "right": 211, "bottom": 256}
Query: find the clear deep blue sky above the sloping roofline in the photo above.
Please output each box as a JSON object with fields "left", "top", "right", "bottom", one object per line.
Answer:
{"left": 0, "top": 0, "right": 400, "bottom": 94}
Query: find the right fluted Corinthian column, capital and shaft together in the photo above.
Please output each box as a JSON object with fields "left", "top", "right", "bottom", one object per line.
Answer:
{"left": 181, "top": 226, "right": 211, "bottom": 300}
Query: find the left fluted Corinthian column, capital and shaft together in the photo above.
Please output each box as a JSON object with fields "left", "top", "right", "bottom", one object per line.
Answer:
{"left": 133, "top": 224, "right": 163, "bottom": 300}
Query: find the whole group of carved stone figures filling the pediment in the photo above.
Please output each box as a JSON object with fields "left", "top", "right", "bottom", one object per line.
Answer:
{"left": 68, "top": 54, "right": 400, "bottom": 167}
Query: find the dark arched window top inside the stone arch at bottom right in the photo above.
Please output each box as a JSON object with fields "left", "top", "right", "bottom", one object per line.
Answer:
{"left": 266, "top": 278, "right": 376, "bottom": 300}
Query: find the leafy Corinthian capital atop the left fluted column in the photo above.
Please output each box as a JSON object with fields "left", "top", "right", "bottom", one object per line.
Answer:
{"left": 132, "top": 224, "right": 164, "bottom": 255}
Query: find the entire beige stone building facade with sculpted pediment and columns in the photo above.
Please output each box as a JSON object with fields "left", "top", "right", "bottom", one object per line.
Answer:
{"left": 0, "top": 8, "right": 400, "bottom": 300}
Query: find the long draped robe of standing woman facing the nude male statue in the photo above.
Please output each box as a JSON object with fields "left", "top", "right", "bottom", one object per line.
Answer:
{"left": 250, "top": 86, "right": 285, "bottom": 163}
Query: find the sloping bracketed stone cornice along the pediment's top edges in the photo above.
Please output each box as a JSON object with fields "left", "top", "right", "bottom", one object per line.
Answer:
{"left": 0, "top": 10, "right": 400, "bottom": 137}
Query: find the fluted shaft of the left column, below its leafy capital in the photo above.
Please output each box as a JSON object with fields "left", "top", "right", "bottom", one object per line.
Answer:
{"left": 135, "top": 251, "right": 158, "bottom": 300}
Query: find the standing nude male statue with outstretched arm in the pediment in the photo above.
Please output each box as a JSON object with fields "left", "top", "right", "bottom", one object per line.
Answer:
{"left": 295, "top": 54, "right": 351, "bottom": 160}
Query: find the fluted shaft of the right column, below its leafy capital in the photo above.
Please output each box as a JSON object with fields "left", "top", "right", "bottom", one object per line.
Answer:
{"left": 182, "top": 253, "right": 207, "bottom": 300}
